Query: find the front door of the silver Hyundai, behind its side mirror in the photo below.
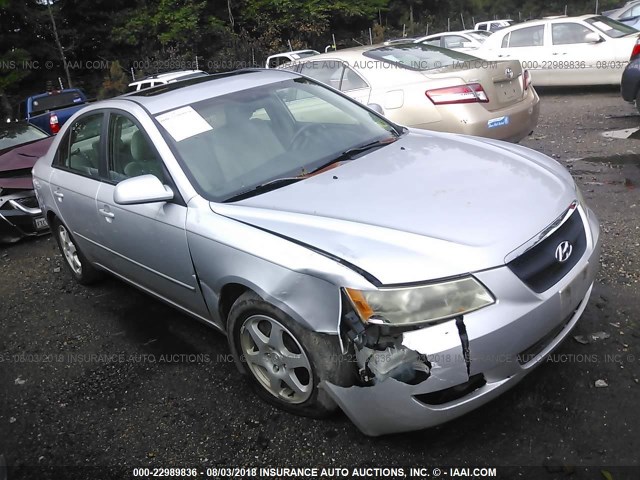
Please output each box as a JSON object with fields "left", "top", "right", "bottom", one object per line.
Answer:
{"left": 96, "top": 111, "right": 209, "bottom": 317}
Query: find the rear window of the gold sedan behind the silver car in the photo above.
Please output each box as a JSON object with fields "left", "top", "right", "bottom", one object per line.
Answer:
{"left": 364, "top": 43, "right": 481, "bottom": 71}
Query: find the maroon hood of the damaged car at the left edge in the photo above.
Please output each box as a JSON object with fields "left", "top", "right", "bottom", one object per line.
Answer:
{"left": 0, "top": 137, "right": 54, "bottom": 189}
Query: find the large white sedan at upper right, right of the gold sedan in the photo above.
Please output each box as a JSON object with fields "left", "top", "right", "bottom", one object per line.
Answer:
{"left": 474, "top": 15, "right": 640, "bottom": 87}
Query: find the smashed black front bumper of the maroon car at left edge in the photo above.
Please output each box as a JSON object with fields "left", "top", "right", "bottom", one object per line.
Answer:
{"left": 0, "top": 190, "right": 49, "bottom": 243}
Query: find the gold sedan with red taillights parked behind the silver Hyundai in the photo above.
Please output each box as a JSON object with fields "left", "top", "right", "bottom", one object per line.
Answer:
{"left": 284, "top": 43, "right": 540, "bottom": 142}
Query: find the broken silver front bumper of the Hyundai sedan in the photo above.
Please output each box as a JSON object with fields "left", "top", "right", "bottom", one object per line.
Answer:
{"left": 320, "top": 204, "right": 601, "bottom": 436}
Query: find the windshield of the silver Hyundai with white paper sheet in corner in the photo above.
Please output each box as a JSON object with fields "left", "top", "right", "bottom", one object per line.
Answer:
{"left": 156, "top": 78, "right": 398, "bottom": 202}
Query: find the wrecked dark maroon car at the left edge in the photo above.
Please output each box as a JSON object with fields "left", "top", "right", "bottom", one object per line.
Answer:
{"left": 0, "top": 122, "right": 53, "bottom": 243}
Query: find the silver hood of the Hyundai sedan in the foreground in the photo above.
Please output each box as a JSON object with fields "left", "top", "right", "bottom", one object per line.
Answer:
{"left": 211, "top": 130, "right": 576, "bottom": 285}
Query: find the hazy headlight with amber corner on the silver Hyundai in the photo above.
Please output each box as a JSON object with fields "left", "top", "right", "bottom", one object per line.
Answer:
{"left": 345, "top": 276, "right": 495, "bottom": 325}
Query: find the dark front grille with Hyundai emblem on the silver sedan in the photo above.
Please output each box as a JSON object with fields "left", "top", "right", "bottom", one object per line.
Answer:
{"left": 507, "top": 208, "right": 587, "bottom": 293}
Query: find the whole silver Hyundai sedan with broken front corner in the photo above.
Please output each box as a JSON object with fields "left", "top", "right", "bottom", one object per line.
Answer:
{"left": 33, "top": 70, "right": 600, "bottom": 435}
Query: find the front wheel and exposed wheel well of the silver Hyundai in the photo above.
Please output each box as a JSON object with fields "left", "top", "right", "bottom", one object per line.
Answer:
{"left": 227, "top": 292, "right": 357, "bottom": 418}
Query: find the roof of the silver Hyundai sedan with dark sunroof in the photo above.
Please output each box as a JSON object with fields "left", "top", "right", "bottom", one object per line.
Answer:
{"left": 118, "top": 69, "right": 301, "bottom": 115}
